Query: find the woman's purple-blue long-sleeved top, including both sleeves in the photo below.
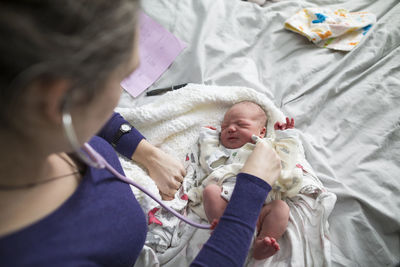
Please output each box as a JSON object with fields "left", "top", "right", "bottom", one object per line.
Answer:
{"left": 0, "top": 113, "right": 271, "bottom": 266}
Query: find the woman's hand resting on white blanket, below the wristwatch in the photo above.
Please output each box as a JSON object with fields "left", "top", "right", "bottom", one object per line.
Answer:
{"left": 132, "top": 139, "right": 186, "bottom": 200}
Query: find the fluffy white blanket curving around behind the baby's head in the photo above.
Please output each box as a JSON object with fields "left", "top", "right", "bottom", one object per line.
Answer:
{"left": 116, "top": 84, "right": 285, "bottom": 206}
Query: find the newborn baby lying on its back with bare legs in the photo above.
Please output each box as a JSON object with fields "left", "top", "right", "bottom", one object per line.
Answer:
{"left": 199, "top": 101, "right": 294, "bottom": 260}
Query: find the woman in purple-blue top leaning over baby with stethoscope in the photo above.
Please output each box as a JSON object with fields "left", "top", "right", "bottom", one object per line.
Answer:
{"left": 0, "top": 0, "right": 280, "bottom": 266}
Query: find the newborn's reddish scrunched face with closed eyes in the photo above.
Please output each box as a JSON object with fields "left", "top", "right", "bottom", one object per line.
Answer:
{"left": 221, "top": 104, "right": 265, "bottom": 149}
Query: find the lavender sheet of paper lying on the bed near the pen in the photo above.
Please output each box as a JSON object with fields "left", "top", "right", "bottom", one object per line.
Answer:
{"left": 121, "top": 12, "right": 186, "bottom": 97}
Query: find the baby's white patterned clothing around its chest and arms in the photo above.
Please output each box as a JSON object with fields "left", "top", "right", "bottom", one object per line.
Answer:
{"left": 188, "top": 127, "right": 306, "bottom": 222}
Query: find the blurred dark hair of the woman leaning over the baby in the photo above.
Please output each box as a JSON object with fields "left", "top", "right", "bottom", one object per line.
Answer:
{"left": 0, "top": 0, "right": 139, "bottom": 128}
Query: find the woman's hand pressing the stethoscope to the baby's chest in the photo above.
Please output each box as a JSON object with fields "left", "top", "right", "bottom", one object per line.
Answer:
{"left": 241, "top": 140, "right": 281, "bottom": 186}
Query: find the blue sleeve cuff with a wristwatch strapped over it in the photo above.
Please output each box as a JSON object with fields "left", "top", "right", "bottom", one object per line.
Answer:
{"left": 97, "top": 112, "right": 144, "bottom": 159}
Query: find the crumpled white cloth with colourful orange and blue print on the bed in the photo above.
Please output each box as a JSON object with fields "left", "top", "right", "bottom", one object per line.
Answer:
{"left": 285, "top": 8, "right": 376, "bottom": 51}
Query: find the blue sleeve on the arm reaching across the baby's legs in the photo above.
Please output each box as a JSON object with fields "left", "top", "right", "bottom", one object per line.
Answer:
{"left": 191, "top": 173, "right": 271, "bottom": 267}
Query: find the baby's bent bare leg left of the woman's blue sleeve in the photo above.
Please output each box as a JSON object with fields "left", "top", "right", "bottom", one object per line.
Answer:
{"left": 203, "top": 184, "right": 228, "bottom": 223}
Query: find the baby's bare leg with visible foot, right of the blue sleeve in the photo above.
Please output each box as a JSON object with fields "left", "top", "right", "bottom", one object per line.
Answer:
{"left": 253, "top": 200, "right": 289, "bottom": 260}
